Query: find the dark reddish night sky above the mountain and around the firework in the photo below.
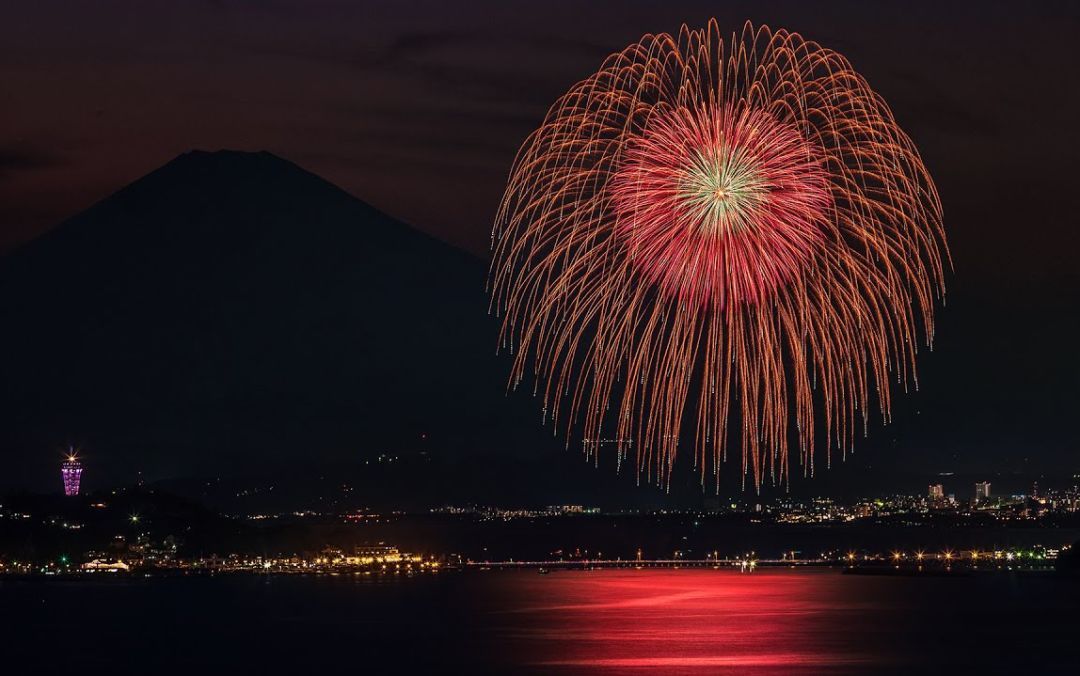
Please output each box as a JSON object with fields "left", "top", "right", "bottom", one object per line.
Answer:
{"left": 0, "top": 0, "right": 1080, "bottom": 481}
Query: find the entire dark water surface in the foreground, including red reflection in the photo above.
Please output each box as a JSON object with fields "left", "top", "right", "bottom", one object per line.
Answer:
{"left": 0, "top": 569, "right": 1080, "bottom": 674}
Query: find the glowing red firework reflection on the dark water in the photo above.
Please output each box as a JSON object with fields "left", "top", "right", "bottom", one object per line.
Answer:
{"left": 494, "top": 569, "right": 873, "bottom": 674}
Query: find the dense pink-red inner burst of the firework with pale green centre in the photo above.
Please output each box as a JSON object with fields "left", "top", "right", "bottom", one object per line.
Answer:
{"left": 611, "top": 106, "right": 829, "bottom": 307}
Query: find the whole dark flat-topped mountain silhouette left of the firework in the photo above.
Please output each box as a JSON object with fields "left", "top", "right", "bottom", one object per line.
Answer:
{"left": 0, "top": 151, "right": 613, "bottom": 496}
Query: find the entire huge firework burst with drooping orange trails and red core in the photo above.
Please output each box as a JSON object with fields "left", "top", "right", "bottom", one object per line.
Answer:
{"left": 490, "top": 22, "right": 948, "bottom": 487}
